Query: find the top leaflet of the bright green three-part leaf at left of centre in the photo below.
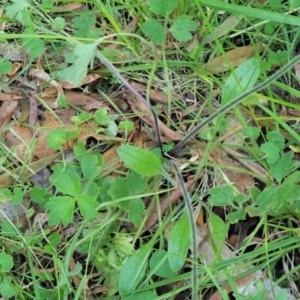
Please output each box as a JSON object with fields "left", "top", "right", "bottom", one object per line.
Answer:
{"left": 50, "top": 174, "right": 80, "bottom": 197}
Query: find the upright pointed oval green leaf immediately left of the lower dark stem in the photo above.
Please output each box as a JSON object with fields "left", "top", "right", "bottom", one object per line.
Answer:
{"left": 168, "top": 212, "right": 191, "bottom": 272}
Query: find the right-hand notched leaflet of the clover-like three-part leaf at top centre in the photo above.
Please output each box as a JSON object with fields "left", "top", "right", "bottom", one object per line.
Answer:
{"left": 170, "top": 15, "right": 197, "bottom": 42}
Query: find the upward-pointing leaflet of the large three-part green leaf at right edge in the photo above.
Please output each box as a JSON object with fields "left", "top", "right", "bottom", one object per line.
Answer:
{"left": 270, "top": 151, "right": 296, "bottom": 183}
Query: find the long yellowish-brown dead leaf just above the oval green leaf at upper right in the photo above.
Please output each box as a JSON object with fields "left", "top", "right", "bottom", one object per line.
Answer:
{"left": 203, "top": 44, "right": 264, "bottom": 74}
